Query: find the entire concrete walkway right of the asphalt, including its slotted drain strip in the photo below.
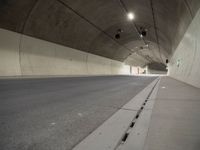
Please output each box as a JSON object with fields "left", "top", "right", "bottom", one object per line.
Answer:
{"left": 74, "top": 77, "right": 200, "bottom": 150}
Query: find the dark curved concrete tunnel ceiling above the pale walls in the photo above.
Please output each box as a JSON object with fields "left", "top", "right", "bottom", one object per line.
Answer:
{"left": 0, "top": 0, "right": 200, "bottom": 69}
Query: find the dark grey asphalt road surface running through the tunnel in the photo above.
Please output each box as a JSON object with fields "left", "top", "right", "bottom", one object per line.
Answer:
{"left": 0, "top": 76, "right": 155, "bottom": 150}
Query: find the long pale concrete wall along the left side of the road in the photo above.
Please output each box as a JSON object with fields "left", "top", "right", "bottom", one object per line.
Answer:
{"left": 0, "top": 29, "right": 130, "bottom": 76}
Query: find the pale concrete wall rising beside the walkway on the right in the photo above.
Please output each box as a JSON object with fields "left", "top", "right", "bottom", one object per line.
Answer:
{"left": 168, "top": 9, "right": 200, "bottom": 88}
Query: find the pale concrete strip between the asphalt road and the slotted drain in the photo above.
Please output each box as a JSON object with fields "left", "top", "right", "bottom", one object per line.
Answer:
{"left": 73, "top": 78, "right": 158, "bottom": 150}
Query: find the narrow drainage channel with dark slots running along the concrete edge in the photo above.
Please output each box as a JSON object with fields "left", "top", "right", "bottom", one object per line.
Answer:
{"left": 114, "top": 79, "right": 159, "bottom": 150}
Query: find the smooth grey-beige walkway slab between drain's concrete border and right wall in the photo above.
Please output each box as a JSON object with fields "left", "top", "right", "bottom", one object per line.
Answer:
{"left": 144, "top": 77, "right": 200, "bottom": 150}
